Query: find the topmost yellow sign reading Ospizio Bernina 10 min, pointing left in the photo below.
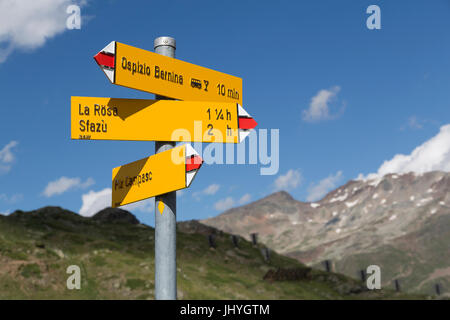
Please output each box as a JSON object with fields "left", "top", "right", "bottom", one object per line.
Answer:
{"left": 94, "top": 41, "right": 242, "bottom": 105}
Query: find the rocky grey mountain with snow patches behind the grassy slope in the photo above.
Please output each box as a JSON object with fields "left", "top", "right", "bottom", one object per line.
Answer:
{"left": 201, "top": 171, "right": 450, "bottom": 294}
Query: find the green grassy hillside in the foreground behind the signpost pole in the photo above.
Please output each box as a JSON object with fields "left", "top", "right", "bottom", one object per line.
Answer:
{"left": 0, "top": 210, "right": 423, "bottom": 299}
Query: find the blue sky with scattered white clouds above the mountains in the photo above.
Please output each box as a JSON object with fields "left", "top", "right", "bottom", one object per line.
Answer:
{"left": 0, "top": 0, "right": 450, "bottom": 225}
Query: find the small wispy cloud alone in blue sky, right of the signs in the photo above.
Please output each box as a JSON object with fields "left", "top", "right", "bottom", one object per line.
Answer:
{"left": 302, "top": 86, "right": 341, "bottom": 122}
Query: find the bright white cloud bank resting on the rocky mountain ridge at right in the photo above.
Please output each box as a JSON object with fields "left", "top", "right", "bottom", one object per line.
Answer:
{"left": 358, "top": 124, "right": 450, "bottom": 179}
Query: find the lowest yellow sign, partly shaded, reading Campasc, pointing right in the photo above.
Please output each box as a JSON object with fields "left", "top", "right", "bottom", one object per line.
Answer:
{"left": 112, "top": 144, "right": 203, "bottom": 208}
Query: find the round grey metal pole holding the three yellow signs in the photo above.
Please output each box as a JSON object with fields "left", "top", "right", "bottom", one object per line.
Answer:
{"left": 154, "top": 37, "right": 177, "bottom": 300}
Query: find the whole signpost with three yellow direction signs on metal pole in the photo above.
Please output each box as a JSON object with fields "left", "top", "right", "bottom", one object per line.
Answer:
{"left": 71, "top": 37, "right": 257, "bottom": 300}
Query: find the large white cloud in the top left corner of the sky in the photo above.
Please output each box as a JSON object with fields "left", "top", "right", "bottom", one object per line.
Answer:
{"left": 0, "top": 0, "right": 86, "bottom": 63}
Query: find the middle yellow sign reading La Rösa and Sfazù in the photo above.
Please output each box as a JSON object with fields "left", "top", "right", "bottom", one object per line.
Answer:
{"left": 71, "top": 97, "right": 256, "bottom": 143}
